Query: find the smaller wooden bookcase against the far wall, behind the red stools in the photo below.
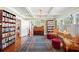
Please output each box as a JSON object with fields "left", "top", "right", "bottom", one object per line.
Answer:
{"left": 47, "top": 20, "right": 56, "bottom": 34}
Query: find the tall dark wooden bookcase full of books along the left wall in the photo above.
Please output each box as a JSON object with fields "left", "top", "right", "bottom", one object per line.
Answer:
{"left": 0, "top": 10, "right": 16, "bottom": 51}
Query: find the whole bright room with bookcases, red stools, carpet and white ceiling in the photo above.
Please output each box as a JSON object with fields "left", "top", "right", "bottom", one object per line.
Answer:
{"left": 0, "top": 7, "right": 79, "bottom": 52}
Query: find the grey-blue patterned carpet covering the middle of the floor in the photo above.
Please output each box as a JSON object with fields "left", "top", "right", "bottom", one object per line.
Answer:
{"left": 19, "top": 36, "right": 63, "bottom": 52}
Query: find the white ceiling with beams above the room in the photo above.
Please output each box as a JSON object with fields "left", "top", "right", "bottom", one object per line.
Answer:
{"left": 6, "top": 7, "right": 78, "bottom": 19}
